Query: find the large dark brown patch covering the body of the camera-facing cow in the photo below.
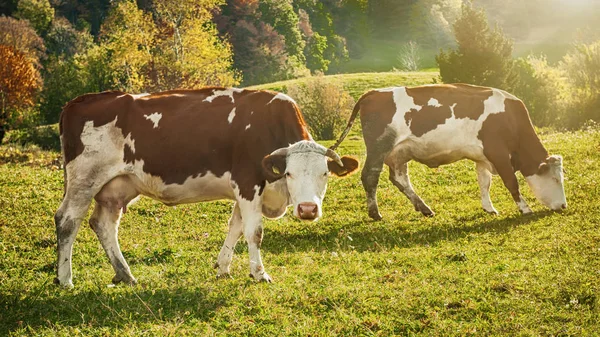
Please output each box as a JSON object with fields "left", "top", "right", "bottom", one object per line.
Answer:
{"left": 60, "top": 88, "right": 308, "bottom": 200}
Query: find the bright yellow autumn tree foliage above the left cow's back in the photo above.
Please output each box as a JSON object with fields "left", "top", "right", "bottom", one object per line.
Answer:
{"left": 90, "top": 0, "right": 239, "bottom": 92}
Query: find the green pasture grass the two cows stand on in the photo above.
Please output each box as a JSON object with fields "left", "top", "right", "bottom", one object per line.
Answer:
{"left": 0, "top": 126, "right": 600, "bottom": 336}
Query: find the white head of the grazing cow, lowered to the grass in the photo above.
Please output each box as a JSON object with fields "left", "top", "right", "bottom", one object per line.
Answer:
{"left": 525, "top": 156, "right": 567, "bottom": 211}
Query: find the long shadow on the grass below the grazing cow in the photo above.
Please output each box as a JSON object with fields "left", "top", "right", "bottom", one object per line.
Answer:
{"left": 263, "top": 211, "right": 554, "bottom": 254}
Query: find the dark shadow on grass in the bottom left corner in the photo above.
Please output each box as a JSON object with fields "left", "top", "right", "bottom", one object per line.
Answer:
{"left": 0, "top": 282, "right": 229, "bottom": 336}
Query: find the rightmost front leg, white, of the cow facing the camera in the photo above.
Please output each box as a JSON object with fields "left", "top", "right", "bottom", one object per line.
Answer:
{"left": 237, "top": 192, "right": 272, "bottom": 282}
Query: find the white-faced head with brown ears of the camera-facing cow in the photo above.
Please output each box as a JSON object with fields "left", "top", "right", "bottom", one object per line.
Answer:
{"left": 262, "top": 140, "right": 358, "bottom": 220}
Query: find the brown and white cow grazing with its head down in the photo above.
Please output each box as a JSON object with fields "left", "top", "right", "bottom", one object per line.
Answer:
{"left": 332, "top": 84, "right": 567, "bottom": 220}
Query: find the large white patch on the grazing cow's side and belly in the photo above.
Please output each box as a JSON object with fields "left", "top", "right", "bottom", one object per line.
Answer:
{"left": 386, "top": 87, "right": 505, "bottom": 167}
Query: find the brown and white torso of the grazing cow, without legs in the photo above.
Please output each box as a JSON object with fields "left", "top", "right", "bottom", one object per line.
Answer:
{"left": 361, "top": 84, "right": 528, "bottom": 166}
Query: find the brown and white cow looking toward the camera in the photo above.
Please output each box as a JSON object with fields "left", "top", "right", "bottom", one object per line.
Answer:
{"left": 55, "top": 88, "right": 358, "bottom": 287}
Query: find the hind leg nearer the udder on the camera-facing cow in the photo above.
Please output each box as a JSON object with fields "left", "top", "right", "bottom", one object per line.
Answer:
{"left": 90, "top": 202, "right": 137, "bottom": 285}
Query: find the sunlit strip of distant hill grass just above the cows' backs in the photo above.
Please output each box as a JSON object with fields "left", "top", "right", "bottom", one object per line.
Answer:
{"left": 248, "top": 70, "right": 439, "bottom": 99}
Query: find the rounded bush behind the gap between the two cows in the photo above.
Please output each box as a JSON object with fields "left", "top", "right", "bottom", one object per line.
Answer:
{"left": 288, "top": 76, "right": 354, "bottom": 140}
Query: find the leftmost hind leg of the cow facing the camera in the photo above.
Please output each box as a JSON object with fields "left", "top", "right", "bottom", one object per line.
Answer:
{"left": 54, "top": 189, "right": 93, "bottom": 288}
